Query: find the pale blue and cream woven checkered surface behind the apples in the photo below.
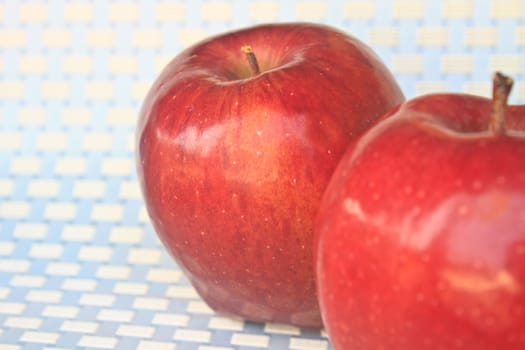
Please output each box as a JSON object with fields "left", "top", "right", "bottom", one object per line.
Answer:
{"left": 0, "top": 0, "right": 525, "bottom": 350}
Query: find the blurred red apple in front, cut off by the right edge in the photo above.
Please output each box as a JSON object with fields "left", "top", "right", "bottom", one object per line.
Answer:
{"left": 314, "top": 74, "right": 525, "bottom": 350}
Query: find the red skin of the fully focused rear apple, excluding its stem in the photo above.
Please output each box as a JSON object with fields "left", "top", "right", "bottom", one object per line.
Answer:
{"left": 136, "top": 23, "right": 404, "bottom": 327}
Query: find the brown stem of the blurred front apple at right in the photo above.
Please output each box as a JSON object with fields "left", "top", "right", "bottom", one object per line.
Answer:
{"left": 489, "top": 72, "right": 514, "bottom": 135}
